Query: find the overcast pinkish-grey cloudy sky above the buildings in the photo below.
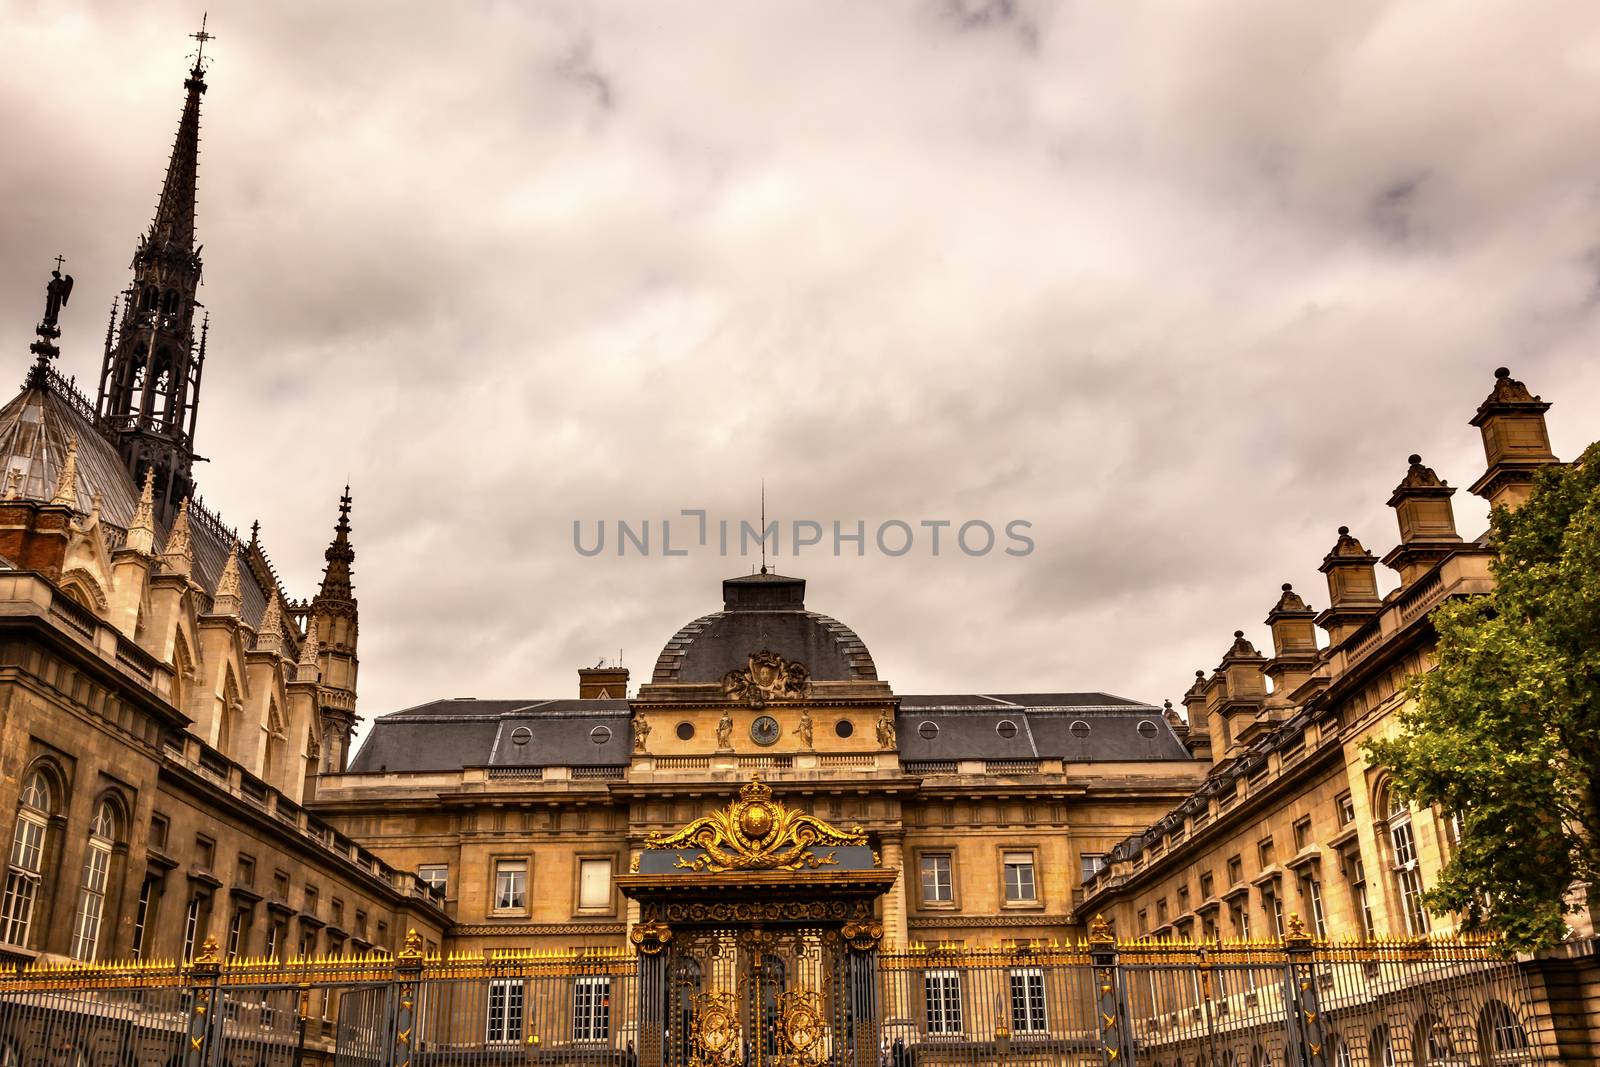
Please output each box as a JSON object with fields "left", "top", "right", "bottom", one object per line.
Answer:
{"left": 0, "top": 0, "right": 1600, "bottom": 739}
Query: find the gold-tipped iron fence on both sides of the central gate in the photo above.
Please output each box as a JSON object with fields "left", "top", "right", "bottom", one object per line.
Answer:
{"left": 0, "top": 936, "right": 1560, "bottom": 1067}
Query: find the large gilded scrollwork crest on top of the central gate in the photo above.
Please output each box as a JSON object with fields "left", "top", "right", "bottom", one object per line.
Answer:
{"left": 645, "top": 774, "right": 867, "bottom": 873}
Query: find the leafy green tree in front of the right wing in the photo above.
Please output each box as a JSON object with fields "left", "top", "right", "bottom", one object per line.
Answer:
{"left": 1366, "top": 443, "right": 1600, "bottom": 949}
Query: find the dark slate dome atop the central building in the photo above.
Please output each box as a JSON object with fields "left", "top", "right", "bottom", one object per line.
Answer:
{"left": 651, "top": 574, "right": 878, "bottom": 683}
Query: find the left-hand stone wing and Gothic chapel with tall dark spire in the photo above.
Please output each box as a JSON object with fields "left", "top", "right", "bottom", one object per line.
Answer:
{"left": 0, "top": 49, "right": 448, "bottom": 961}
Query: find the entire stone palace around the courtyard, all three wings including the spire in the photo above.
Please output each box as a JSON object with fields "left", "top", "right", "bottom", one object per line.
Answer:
{"left": 0, "top": 29, "right": 1600, "bottom": 1048}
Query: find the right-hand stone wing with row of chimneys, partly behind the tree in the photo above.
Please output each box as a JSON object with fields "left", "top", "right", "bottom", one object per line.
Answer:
{"left": 1083, "top": 368, "right": 1600, "bottom": 1062}
